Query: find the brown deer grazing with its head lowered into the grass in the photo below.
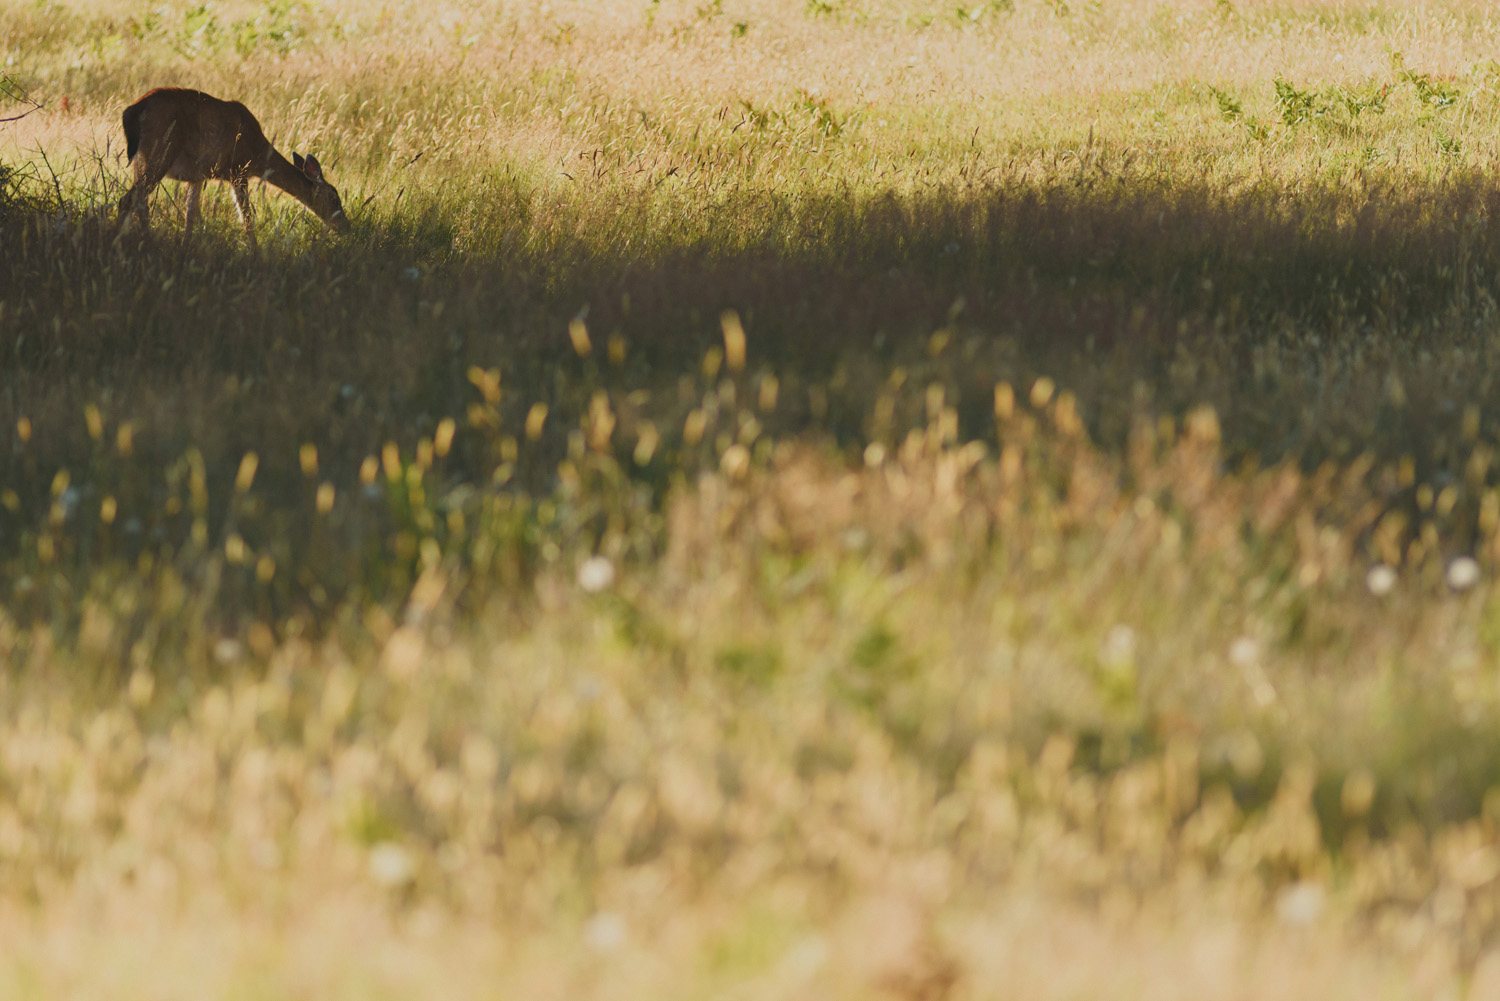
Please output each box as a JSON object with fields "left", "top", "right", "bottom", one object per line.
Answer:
{"left": 117, "top": 87, "right": 350, "bottom": 248}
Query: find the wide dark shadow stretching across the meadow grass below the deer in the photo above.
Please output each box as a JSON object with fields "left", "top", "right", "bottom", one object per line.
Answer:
{"left": 14, "top": 177, "right": 1500, "bottom": 842}
